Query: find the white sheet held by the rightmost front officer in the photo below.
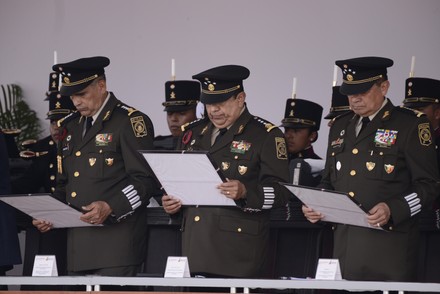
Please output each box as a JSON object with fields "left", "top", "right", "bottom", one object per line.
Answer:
{"left": 281, "top": 183, "right": 383, "bottom": 230}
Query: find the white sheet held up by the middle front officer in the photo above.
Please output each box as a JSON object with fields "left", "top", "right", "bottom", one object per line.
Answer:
{"left": 140, "top": 151, "right": 236, "bottom": 206}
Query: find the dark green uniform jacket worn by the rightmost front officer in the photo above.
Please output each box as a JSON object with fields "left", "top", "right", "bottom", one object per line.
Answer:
{"left": 321, "top": 100, "right": 439, "bottom": 281}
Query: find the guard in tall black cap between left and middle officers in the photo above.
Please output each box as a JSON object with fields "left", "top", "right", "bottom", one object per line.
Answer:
{"left": 154, "top": 81, "right": 200, "bottom": 150}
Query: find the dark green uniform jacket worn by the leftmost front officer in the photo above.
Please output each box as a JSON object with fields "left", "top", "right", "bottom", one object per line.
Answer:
{"left": 55, "top": 94, "right": 154, "bottom": 271}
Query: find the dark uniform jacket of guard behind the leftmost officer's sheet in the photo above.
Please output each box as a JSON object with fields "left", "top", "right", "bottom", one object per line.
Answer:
{"left": 11, "top": 136, "right": 57, "bottom": 194}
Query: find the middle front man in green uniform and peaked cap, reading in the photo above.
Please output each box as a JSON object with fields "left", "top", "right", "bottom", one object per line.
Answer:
{"left": 162, "top": 65, "right": 289, "bottom": 277}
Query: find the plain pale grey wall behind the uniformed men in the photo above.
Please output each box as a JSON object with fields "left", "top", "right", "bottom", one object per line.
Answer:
{"left": 0, "top": 0, "right": 440, "bottom": 156}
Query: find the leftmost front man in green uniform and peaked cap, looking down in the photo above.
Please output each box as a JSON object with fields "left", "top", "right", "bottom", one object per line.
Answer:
{"left": 34, "top": 56, "right": 154, "bottom": 276}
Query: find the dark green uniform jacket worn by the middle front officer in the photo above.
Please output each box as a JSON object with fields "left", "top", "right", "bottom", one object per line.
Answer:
{"left": 178, "top": 109, "right": 289, "bottom": 277}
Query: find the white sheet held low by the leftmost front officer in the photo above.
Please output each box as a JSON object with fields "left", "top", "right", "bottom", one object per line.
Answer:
{"left": 0, "top": 194, "right": 97, "bottom": 228}
